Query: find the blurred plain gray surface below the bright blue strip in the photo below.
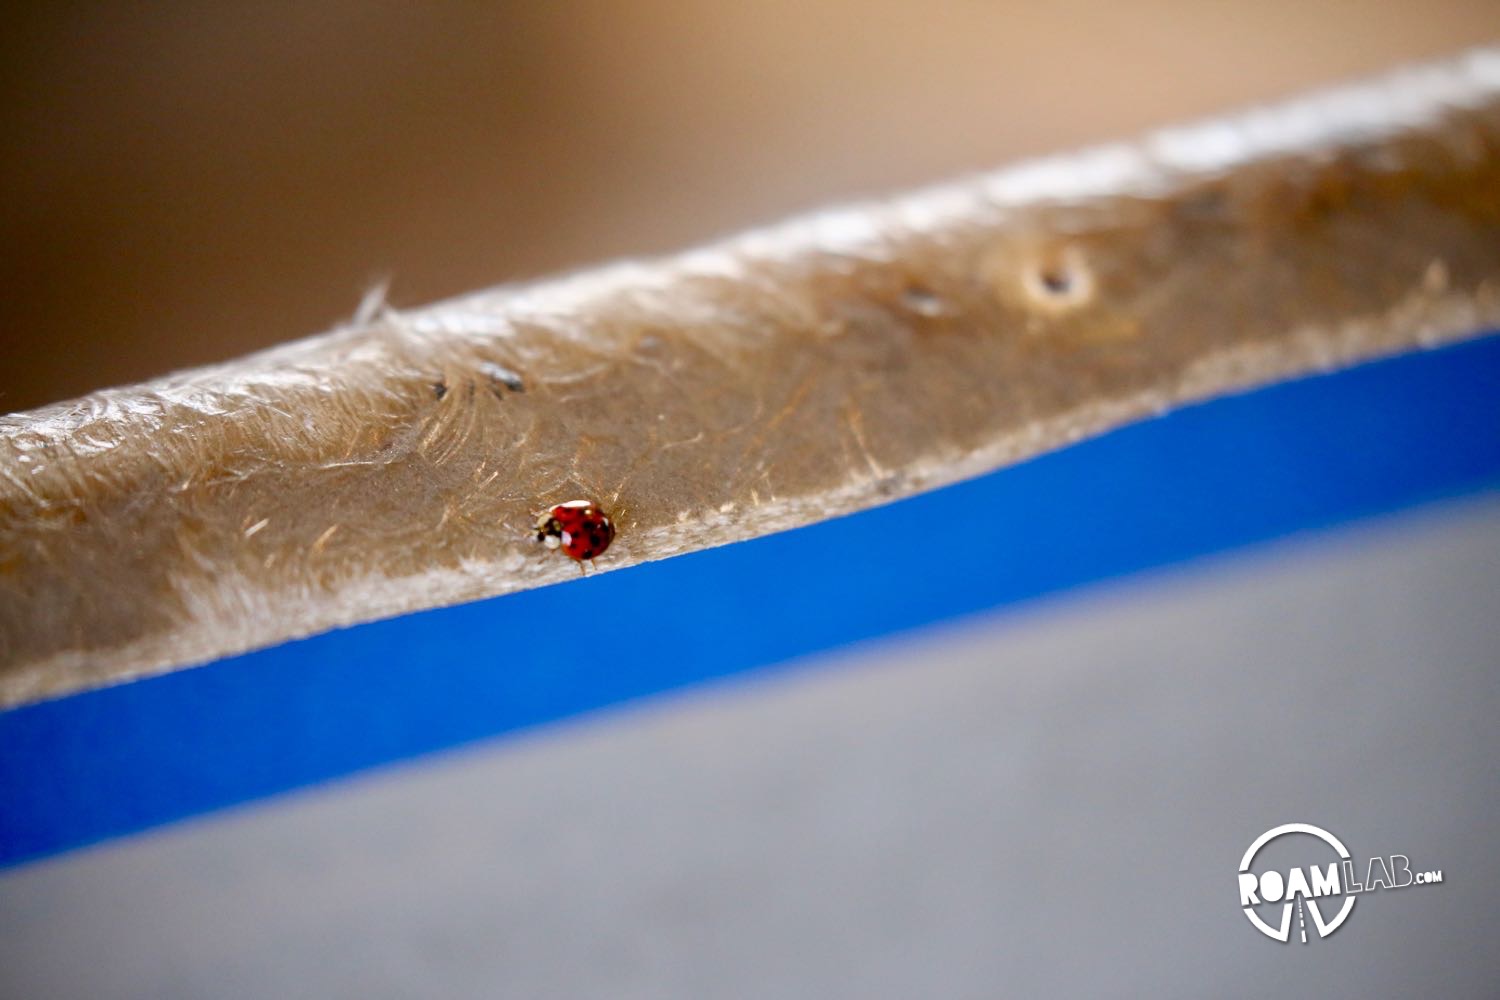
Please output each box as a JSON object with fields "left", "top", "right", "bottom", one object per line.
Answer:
{"left": 0, "top": 498, "right": 1500, "bottom": 997}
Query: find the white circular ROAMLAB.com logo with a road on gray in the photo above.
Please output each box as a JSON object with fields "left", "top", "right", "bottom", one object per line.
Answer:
{"left": 1239, "top": 823, "right": 1443, "bottom": 945}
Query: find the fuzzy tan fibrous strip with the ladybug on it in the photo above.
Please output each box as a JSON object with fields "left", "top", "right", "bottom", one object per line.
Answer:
{"left": 0, "top": 51, "right": 1500, "bottom": 703}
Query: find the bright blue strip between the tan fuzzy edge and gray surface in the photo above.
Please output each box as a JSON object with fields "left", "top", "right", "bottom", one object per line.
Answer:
{"left": 0, "top": 337, "right": 1500, "bottom": 864}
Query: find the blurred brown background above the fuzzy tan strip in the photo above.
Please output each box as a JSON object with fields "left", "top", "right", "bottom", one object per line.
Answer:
{"left": 0, "top": 0, "right": 1500, "bottom": 412}
